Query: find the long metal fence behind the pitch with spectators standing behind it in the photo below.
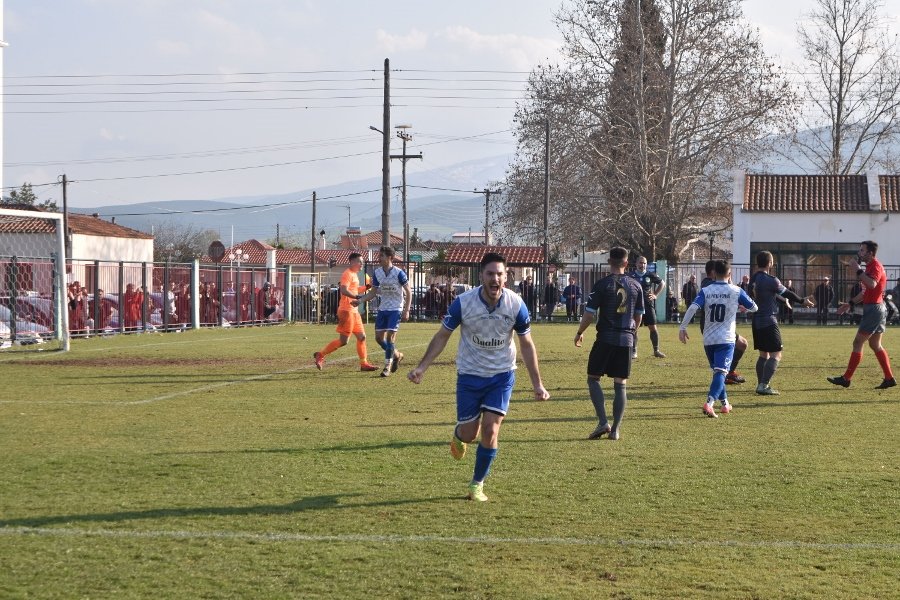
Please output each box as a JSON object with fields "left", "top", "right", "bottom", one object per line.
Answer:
{"left": 10, "top": 255, "right": 900, "bottom": 336}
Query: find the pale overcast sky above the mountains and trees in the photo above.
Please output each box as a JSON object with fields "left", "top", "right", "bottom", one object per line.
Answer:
{"left": 0, "top": 0, "right": 900, "bottom": 207}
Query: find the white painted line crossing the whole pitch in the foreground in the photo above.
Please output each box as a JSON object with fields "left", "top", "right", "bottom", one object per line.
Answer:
{"left": 0, "top": 527, "right": 900, "bottom": 551}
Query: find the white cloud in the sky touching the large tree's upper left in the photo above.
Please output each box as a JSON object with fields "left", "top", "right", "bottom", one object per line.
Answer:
{"left": 436, "top": 26, "right": 559, "bottom": 71}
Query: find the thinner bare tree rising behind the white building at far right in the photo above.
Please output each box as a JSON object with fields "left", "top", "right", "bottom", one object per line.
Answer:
{"left": 793, "top": 0, "right": 900, "bottom": 175}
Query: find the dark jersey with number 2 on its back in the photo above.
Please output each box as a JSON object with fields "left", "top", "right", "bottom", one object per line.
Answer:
{"left": 585, "top": 275, "right": 644, "bottom": 348}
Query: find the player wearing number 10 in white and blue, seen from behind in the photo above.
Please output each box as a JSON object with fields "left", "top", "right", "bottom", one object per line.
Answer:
{"left": 678, "top": 260, "right": 756, "bottom": 418}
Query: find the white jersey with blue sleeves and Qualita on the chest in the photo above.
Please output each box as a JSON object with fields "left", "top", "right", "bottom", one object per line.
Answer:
{"left": 443, "top": 286, "right": 531, "bottom": 377}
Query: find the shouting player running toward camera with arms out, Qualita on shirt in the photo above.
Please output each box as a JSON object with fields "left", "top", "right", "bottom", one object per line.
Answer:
{"left": 408, "top": 252, "right": 550, "bottom": 502}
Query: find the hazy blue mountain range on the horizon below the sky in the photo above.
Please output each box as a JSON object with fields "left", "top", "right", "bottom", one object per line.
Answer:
{"left": 71, "top": 131, "right": 900, "bottom": 246}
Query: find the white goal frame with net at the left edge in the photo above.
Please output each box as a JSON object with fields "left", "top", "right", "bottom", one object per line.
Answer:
{"left": 0, "top": 207, "right": 69, "bottom": 353}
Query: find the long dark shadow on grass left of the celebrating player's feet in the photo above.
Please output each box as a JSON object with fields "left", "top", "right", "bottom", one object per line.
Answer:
{"left": 0, "top": 493, "right": 446, "bottom": 528}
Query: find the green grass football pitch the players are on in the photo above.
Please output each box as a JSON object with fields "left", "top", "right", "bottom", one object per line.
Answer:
{"left": 0, "top": 323, "right": 900, "bottom": 599}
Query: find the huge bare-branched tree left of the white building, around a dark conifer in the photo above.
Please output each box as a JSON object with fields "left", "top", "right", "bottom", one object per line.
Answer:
{"left": 498, "top": 0, "right": 792, "bottom": 261}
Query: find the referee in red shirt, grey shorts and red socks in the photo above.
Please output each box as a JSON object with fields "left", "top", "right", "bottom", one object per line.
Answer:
{"left": 828, "top": 240, "right": 897, "bottom": 390}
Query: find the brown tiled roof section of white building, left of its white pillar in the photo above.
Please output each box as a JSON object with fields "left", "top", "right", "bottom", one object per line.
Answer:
{"left": 743, "top": 175, "right": 869, "bottom": 212}
